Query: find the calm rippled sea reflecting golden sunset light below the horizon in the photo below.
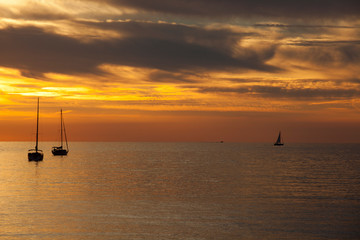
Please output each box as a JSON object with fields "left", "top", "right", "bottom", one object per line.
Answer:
{"left": 0, "top": 142, "right": 360, "bottom": 240}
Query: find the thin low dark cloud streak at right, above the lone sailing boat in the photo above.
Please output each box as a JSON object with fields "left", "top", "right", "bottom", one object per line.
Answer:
{"left": 198, "top": 85, "right": 360, "bottom": 100}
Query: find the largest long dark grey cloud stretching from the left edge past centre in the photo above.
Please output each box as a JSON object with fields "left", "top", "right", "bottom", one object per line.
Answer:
{"left": 0, "top": 22, "right": 278, "bottom": 77}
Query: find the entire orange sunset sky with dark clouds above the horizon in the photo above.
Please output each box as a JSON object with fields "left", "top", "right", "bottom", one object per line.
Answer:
{"left": 0, "top": 0, "right": 360, "bottom": 143}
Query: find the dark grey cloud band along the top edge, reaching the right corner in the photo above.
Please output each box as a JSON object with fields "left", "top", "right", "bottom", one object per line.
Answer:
{"left": 94, "top": 0, "right": 360, "bottom": 18}
